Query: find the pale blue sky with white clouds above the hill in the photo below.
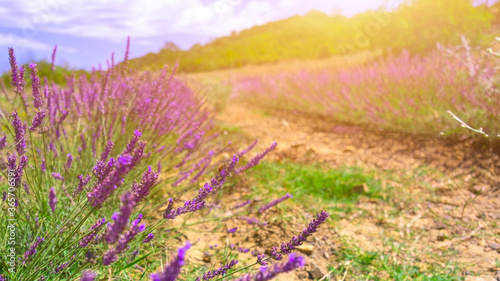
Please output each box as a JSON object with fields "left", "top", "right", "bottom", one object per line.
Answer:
{"left": 0, "top": 0, "right": 492, "bottom": 72}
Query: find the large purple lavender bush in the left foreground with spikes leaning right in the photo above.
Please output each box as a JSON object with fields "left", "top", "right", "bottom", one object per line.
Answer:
{"left": 0, "top": 37, "right": 328, "bottom": 281}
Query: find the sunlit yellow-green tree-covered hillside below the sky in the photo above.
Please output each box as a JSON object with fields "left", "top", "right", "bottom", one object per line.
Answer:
{"left": 131, "top": 0, "right": 493, "bottom": 72}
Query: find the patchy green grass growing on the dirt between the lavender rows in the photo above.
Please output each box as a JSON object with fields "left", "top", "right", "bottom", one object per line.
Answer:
{"left": 242, "top": 162, "right": 464, "bottom": 281}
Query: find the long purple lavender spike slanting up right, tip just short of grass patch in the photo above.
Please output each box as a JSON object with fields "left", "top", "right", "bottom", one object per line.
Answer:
{"left": 163, "top": 155, "right": 239, "bottom": 219}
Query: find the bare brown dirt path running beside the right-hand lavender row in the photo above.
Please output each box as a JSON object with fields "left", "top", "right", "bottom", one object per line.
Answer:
{"left": 216, "top": 101, "right": 500, "bottom": 280}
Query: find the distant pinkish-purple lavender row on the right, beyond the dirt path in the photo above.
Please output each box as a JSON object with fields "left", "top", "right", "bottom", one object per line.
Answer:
{"left": 232, "top": 39, "right": 500, "bottom": 136}
